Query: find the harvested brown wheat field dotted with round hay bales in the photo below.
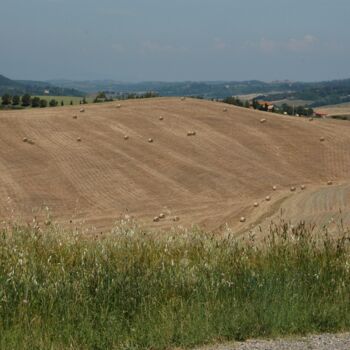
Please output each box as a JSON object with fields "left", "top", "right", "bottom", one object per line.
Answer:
{"left": 0, "top": 98, "right": 350, "bottom": 232}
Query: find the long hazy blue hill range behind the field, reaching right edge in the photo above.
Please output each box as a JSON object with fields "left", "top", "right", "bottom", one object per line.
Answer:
{"left": 50, "top": 79, "right": 350, "bottom": 107}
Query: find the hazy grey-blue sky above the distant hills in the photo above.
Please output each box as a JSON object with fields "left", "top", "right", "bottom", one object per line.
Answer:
{"left": 0, "top": 0, "right": 350, "bottom": 82}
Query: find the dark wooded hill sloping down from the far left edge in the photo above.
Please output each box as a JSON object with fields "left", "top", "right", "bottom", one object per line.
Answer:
{"left": 0, "top": 74, "right": 85, "bottom": 96}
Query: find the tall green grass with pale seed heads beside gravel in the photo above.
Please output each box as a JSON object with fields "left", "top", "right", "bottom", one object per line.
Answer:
{"left": 0, "top": 222, "right": 350, "bottom": 349}
